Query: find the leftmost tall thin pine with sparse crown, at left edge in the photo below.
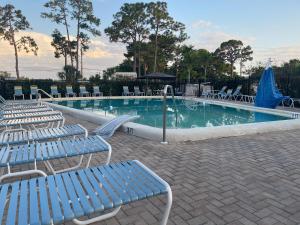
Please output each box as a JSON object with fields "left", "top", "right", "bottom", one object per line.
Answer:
{"left": 0, "top": 4, "right": 38, "bottom": 79}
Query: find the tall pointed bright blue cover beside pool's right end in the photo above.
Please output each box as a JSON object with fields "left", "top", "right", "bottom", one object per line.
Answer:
{"left": 255, "top": 66, "right": 288, "bottom": 109}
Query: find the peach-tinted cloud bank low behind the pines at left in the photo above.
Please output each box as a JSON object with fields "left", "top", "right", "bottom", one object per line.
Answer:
{"left": 0, "top": 32, "right": 125, "bottom": 78}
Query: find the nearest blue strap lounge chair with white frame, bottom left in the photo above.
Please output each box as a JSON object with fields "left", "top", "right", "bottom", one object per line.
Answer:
{"left": 0, "top": 161, "right": 172, "bottom": 225}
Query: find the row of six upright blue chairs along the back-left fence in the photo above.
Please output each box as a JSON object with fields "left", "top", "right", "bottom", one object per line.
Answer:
{"left": 14, "top": 85, "right": 103, "bottom": 100}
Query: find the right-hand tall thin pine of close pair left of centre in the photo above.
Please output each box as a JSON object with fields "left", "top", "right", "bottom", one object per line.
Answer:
{"left": 70, "top": 0, "right": 101, "bottom": 71}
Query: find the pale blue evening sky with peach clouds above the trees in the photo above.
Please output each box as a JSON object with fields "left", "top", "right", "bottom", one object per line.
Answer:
{"left": 0, "top": 0, "right": 300, "bottom": 78}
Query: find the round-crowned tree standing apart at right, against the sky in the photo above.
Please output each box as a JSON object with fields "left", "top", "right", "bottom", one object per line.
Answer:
{"left": 215, "top": 40, "right": 253, "bottom": 76}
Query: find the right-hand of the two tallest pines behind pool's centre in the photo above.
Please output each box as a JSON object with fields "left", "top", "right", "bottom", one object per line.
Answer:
{"left": 147, "top": 1, "right": 187, "bottom": 72}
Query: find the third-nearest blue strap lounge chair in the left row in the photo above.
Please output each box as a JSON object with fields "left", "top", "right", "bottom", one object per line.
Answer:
{"left": 0, "top": 124, "right": 88, "bottom": 146}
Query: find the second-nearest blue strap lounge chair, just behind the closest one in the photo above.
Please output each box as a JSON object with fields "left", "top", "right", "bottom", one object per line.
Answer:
{"left": 0, "top": 136, "right": 111, "bottom": 183}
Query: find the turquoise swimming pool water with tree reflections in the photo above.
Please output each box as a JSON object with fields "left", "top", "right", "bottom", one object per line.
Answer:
{"left": 56, "top": 99, "right": 291, "bottom": 128}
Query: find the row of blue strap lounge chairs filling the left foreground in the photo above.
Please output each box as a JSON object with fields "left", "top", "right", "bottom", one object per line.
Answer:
{"left": 0, "top": 96, "right": 172, "bottom": 225}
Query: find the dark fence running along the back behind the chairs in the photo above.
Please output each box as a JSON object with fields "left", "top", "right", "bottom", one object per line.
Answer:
{"left": 0, "top": 75, "right": 300, "bottom": 99}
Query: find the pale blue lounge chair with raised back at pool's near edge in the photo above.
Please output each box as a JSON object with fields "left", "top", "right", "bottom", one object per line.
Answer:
{"left": 94, "top": 115, "right": 140, "bottom": 139}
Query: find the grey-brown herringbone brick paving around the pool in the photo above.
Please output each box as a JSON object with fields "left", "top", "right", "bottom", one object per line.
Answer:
{"left": 57, "top": 110, "right": 300, "bottom": 225}
